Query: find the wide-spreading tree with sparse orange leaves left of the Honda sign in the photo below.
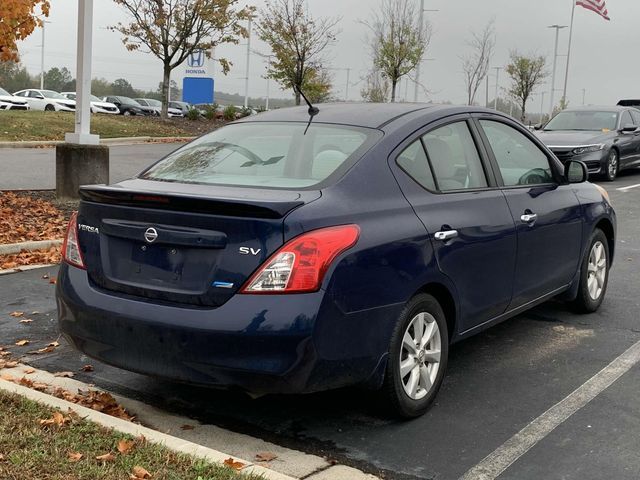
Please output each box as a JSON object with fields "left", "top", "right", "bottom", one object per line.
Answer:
{"left": 111, "top": 0, "right": 253, "bottom": 117}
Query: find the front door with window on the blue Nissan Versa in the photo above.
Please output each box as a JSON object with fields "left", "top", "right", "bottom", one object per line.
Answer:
{"left": 477, "top": 116, "right": 582, "bottom": 308}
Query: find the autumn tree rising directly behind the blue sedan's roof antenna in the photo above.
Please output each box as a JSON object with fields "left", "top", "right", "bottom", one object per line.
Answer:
{"left": 257, "top": 0, "right": 340, "bottom": 105}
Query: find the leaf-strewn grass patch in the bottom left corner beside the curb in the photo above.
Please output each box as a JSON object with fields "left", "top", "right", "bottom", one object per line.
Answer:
{"left": 0, "top": 391, "right": 262, "bottom": 480}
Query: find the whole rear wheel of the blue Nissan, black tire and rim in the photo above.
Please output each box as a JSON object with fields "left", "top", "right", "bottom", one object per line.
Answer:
{"left": 381, "top": 293, "right": 449, "bottom": 418}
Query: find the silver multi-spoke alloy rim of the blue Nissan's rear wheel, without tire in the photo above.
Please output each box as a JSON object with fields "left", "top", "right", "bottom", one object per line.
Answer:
{"left": 399, "top": 312, "right": 442, "bottom": 400}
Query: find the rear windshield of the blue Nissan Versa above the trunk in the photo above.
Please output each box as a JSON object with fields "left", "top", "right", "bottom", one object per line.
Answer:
{"left": 141, "top": 122, "right": 382, "bottom": 188}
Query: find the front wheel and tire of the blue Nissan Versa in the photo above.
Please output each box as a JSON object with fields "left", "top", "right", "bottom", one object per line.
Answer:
{"left": 572, "top": 229, "right": 611, "bottom": 313}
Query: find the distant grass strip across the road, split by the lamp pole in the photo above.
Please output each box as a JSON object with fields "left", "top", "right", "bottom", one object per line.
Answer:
{"left": 0, "top": 110, "right": 220, "bottom": 142}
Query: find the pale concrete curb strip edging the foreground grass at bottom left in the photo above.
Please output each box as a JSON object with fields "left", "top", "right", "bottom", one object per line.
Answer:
{"left": 0, "top": 379, "right": 296, "bottom": 480}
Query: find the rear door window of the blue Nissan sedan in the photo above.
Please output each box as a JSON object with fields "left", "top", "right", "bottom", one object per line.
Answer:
{"left": 422, "top": 121, "right": 487, "bottom": 192}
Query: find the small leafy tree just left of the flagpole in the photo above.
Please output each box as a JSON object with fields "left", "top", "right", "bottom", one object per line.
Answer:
{"left": 506, "top": 50, "right": 548, "bottom": 122}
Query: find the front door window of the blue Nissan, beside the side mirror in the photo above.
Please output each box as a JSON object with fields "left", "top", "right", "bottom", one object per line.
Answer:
{"left": 480, "top": 120, "right": 554, "bottom": 187}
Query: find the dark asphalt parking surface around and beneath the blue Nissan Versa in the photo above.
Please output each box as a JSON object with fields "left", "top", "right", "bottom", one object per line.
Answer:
{"left": 0, "top": 169, "right": 640, "bottom": 480}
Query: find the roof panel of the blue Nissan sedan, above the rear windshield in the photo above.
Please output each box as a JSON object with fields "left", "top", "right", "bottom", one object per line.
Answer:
{"left": 235, "top": 102, "right": 442, "bottom": 128}
